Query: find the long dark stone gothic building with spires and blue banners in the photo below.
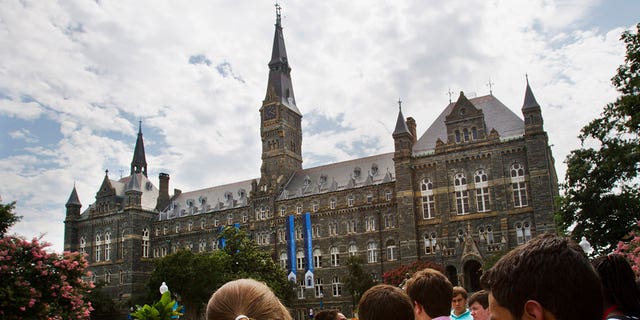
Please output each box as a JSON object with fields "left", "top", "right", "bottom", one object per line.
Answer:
{"left": 64, "top": 8, "right": 558, "bottom": 319}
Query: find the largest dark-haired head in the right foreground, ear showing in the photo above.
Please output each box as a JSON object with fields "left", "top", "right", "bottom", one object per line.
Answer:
{"left": 481, "top": 234, "right": 602, "bottom": 320}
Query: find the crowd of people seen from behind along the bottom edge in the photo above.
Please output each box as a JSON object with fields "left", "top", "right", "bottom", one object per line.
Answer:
{"left": 206, "top": 234, "right": 640, "bottom": 320}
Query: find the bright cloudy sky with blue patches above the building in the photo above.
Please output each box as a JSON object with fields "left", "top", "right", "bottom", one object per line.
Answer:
{"left": 0, "top": 0, "right": 640, "bottom": 252}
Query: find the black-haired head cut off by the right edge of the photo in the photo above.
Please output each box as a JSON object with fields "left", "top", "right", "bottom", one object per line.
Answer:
{"left": 593, "top": 254, "right": 640, "bottom": 316}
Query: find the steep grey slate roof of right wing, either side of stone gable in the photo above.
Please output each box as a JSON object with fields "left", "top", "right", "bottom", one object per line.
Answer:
{"left": 413, "top": 95, "right": 524, "bottom": 155}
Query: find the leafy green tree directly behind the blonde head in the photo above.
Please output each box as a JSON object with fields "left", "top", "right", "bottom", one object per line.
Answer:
{"left": 147, "top": 227, "right": 294, "bottom": 318}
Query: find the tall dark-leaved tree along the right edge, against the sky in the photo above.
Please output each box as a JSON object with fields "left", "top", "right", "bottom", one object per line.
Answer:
{"left": 556, "top": 24, "right": 640, "bottom": 252}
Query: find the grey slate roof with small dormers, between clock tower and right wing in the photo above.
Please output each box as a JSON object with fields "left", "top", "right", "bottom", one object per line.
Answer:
{"left": 278, "top": 153, "right": 395, "bottom": 200}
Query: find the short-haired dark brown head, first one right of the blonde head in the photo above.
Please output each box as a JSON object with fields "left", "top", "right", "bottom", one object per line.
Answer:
{"left": 358, "top": 284, "right": 413, "bottom": 320}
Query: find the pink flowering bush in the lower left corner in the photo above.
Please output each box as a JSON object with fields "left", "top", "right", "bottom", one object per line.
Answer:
{"left": 0, "top": 236, "right": 93, "bottom": 319}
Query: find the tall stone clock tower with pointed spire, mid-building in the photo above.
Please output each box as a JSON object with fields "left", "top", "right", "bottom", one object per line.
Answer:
{"left": 258, "top": 5, "right": 302, "bottom": 193}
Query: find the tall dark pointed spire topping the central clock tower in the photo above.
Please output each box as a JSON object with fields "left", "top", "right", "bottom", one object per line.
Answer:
{"left": 265, "top": 4, "right": 301, "bottom": 115}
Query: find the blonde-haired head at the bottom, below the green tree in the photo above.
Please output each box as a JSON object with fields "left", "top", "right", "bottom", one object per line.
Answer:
{"left": 207, "top": 279, "right": 291, "bottom": 320}
